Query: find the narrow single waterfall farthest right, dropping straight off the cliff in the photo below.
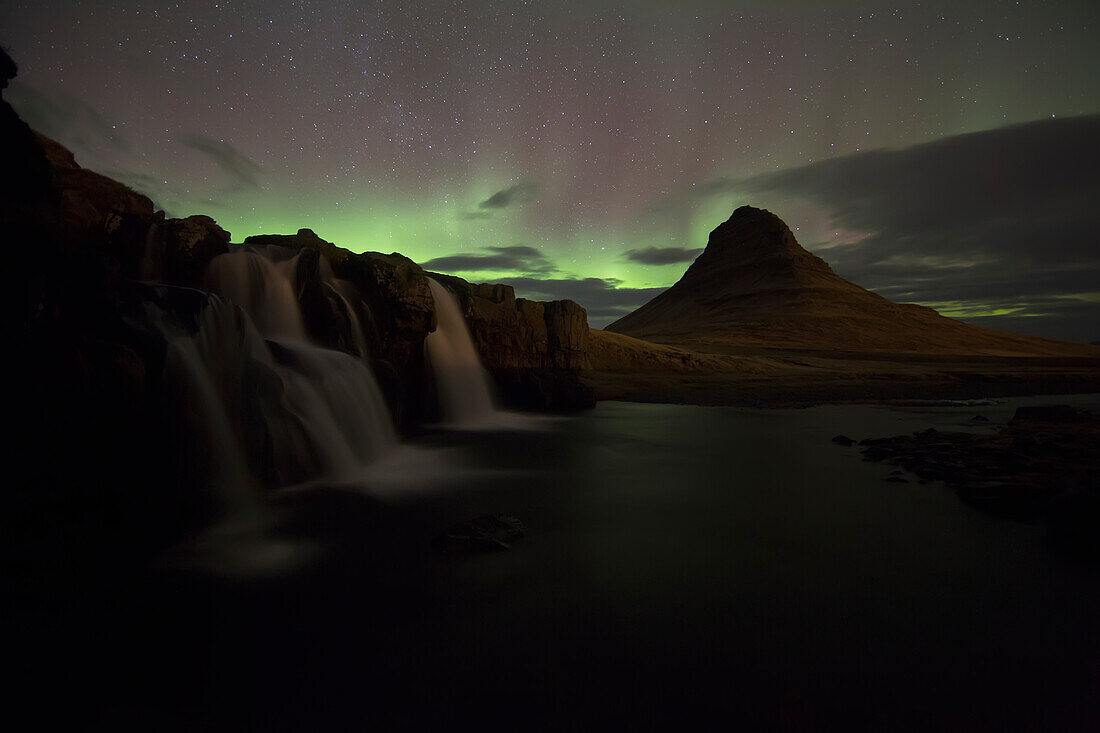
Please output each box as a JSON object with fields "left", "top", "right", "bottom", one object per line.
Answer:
{"left": 424, "top": 277, "right": 496, "bottom": 425}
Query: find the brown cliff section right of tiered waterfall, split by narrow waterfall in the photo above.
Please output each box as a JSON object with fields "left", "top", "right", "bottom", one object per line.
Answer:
{"left": 245, "top": 229, "right": 595, "bottom": 413}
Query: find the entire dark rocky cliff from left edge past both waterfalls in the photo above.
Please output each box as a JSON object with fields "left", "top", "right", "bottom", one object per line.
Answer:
{"left": 4, "top": 77, "right": 594, "bottom": 429}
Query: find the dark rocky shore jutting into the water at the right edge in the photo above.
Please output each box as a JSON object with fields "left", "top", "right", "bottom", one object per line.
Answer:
{"left": 859, "top": 405, "right": 1100, "bottom": 556}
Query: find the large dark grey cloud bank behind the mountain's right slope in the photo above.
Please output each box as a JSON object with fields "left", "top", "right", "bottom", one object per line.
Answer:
{"left": 725, "top": 116, "right": 1100, "bottom": 340}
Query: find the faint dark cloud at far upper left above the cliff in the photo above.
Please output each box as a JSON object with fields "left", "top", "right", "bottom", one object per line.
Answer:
{"left": 6, "top": 79, "right": 130, "bottom": 153}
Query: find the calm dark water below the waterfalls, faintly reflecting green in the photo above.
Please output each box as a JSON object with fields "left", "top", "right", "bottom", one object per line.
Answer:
{"left": 113, "top": 396, "right": 1100, "bottom": 730}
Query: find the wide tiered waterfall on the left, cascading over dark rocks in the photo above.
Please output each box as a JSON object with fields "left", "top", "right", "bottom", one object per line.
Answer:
{"left": 184, "top": 248, "right": 397, "bottom": 485}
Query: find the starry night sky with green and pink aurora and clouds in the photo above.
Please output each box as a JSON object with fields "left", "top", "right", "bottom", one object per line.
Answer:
{"left": 0, "top": 0, "right": 1100, "bottom": 341}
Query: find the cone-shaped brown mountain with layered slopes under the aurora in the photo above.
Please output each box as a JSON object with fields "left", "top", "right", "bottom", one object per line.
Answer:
{"left": 607, "top": 206, "right": 1097, "bottom": 355}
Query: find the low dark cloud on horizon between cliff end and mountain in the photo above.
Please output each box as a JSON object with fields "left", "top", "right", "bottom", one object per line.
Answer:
{"left": 501, "top": 277, "right": 668, "bottom": 328}
